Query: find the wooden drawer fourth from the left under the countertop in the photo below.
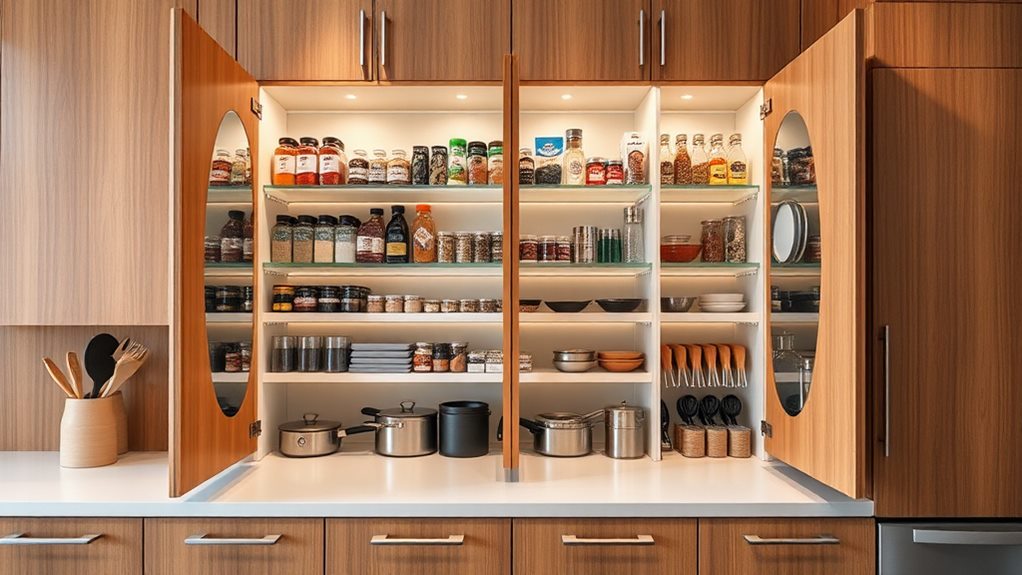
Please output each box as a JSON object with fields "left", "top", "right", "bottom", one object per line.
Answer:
{"left": 514, "top": 519, "right": 696, "bottom": 575}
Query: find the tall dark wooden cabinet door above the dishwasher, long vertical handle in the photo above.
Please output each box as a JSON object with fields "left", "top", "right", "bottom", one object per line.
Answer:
{"left": 871, "top": 68, "right": 1022, "bottom": 518}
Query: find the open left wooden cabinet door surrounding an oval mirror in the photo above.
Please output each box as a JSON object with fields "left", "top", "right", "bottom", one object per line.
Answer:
{"left": 170, "top": 9, "right": 259, "bottom": 496}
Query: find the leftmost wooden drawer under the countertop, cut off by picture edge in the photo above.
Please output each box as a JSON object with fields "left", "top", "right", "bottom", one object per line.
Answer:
{"left": 0, "top": 518, "right": 142, "bottom": 575}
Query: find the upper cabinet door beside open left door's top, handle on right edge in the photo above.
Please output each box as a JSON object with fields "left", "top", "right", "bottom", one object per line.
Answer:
{"left": 237, "top": 0, "right": 373, "bottom": 82}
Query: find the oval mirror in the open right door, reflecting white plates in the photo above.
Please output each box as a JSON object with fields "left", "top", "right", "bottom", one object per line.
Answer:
{"left": 770, "top": 111, "right": 822, "bottom": 416}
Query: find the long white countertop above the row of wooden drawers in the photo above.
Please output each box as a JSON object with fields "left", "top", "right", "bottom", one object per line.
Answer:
{"left": 0, "top": 451, "right": 873, "bottom": 517}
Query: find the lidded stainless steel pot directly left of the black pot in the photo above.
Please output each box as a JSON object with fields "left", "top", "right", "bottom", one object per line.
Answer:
{"left": 362, "top": 401, "right": 436, "bottom": 458}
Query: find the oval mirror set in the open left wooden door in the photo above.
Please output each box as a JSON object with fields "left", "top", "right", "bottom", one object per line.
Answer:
{"left": 204, "top": 111, "right": 254, "bottom": 417}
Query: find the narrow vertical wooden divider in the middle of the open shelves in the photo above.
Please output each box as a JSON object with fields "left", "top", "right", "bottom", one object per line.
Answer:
{"left": 502, "top": 54, "right": 521, "bottom": 482}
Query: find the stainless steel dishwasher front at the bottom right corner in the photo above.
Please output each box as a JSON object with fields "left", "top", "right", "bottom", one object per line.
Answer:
{"left": 879, "top": 522, "right": 1022, "bottom": 575}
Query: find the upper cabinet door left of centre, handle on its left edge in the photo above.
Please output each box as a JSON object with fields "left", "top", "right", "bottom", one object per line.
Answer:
{"left": 375, "top": 0, "right": 511, "bottom": 83}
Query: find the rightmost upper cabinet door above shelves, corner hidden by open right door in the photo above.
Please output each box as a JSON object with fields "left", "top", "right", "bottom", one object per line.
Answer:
{"left": 652, "top": 0, "right": 799, "bottom": 82}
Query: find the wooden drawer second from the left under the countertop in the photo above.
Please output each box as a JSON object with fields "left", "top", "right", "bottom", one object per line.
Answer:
{"left": 145, "top": 519, "right": 323, "bottom": 575}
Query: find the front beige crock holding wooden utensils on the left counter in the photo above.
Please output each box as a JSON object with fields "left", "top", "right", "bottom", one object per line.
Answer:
{"left": 60, "top": 395, "right": 118, "bottom": 468}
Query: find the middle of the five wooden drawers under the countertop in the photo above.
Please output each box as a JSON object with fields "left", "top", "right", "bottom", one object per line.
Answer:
{"left": 326, "top": 519, "right": 511, "bottom": 575}
